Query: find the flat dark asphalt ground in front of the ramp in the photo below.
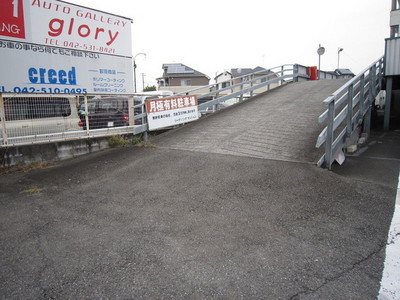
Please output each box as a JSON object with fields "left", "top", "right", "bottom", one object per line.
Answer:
{"left": 0, "top": 133, "right": 400, "bottom": 300}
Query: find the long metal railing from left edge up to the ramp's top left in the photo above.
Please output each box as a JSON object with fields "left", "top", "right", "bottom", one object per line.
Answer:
{"left": 0, "top": 65, "right": 308, "bottom": 147}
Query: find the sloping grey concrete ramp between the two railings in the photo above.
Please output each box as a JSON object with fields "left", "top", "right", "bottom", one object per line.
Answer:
{"left": 153, "top": 79, "right": 346, "bottom": 163}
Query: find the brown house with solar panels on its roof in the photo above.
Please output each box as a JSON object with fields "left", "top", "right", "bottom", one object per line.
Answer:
{"left": 157, "top": 63, "right": 210, "bottom": 94}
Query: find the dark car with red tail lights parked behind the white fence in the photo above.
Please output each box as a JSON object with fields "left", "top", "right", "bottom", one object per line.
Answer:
{"left": 78, "top": 96, "right": 129, "bottom": 130}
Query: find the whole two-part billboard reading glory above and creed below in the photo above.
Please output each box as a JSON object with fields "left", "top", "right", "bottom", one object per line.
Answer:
{"left": 0, "top": 0, "right": 134, "bottom": 94}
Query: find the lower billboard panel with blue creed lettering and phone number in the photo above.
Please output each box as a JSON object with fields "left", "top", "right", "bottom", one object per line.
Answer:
{"left": 0, "top": 40, "right": 133, "bottom": 94}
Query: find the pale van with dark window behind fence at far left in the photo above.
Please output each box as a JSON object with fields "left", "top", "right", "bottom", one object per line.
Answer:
{"left": 0, "top": 95, "right": 82, "bottom": 137}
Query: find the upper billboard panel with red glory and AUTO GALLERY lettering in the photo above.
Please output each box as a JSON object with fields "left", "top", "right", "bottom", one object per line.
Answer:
{"left": 0, "top": 0, "right": 132, "bottom": 56}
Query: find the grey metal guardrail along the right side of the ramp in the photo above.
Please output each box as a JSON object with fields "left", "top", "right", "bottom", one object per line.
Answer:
{"left": 316, "top": 57, "right": 384, "bottom": 169}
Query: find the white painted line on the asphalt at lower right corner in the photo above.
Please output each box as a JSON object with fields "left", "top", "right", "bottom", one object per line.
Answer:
{"left": 378, "top": 174, "right": 400, "bottom": 300}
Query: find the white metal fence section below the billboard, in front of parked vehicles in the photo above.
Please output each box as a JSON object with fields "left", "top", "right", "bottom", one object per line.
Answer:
{"left": 0, "top": 93, "right": 147, "bottom": 147}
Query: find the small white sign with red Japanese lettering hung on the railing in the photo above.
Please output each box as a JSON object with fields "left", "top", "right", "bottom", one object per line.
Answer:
{"left": 146, "top": 96, "right": 199, "bottom": 130}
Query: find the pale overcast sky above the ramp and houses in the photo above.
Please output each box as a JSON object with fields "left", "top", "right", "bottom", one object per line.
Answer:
{"left": 66, "top": 0, "right": 391, "bottom": 91}
